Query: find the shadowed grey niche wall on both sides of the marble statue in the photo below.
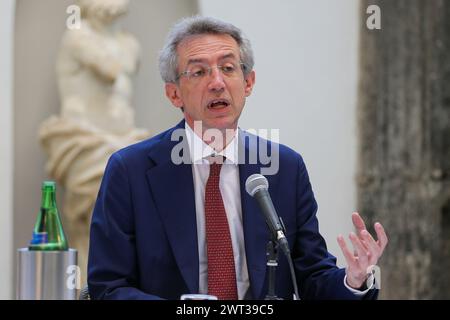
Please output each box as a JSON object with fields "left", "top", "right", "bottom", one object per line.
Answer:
{"left": 14, "top": 0, "right": 197, "bottom": 268}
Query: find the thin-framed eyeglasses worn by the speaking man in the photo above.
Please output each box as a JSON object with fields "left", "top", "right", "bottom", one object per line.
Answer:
{"left": 175, "top": 62, "right": 245, "bottom": 82}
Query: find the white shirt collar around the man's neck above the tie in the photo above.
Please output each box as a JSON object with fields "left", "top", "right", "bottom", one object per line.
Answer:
{"left": 184, "top": 122, "right": 239, "bottom": 165}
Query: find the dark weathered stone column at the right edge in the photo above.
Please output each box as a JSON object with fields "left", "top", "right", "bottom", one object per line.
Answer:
{"left": 357, "top": 0, "right": 450, "bottom": 299}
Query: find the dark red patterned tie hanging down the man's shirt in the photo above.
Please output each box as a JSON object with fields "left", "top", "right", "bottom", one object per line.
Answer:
{"left": 205, "top": 163, "right": 238, "bottom": 300}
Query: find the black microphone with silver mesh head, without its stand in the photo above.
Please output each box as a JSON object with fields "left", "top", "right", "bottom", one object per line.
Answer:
{"left": 245, "top": 174, "right": 291, "bottom": 258}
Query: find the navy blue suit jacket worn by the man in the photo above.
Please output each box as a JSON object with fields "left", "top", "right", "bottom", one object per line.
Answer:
{"left": 88, "top": 121, "right": 377, "bottom": 299}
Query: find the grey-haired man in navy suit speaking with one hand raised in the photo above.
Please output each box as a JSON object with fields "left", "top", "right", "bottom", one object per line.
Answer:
{"left": 88, "top": 17, "right": 387, "bottom": 299}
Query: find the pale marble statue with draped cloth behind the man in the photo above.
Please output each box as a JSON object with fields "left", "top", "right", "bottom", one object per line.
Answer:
{"left": 39, "top": 0, "right": 149, "bottom": 283}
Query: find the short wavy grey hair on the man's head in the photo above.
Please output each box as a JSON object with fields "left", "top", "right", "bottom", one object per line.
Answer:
{"left": 159, "top": 15, "right": 254, "bottom": 83}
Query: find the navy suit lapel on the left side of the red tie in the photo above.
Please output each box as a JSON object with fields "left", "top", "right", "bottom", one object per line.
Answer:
{"left": 147, "top": 121, "right": 199, "bottom": 293}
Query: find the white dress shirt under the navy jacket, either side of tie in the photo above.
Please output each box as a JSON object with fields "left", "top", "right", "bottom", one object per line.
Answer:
{"left": 185, "top": 124, "right": 250, "bottom": 300}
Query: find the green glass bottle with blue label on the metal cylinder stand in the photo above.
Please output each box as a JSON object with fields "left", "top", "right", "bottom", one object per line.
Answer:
{"left": 28, "top": 181, "right": 69, "bottom": 251}
